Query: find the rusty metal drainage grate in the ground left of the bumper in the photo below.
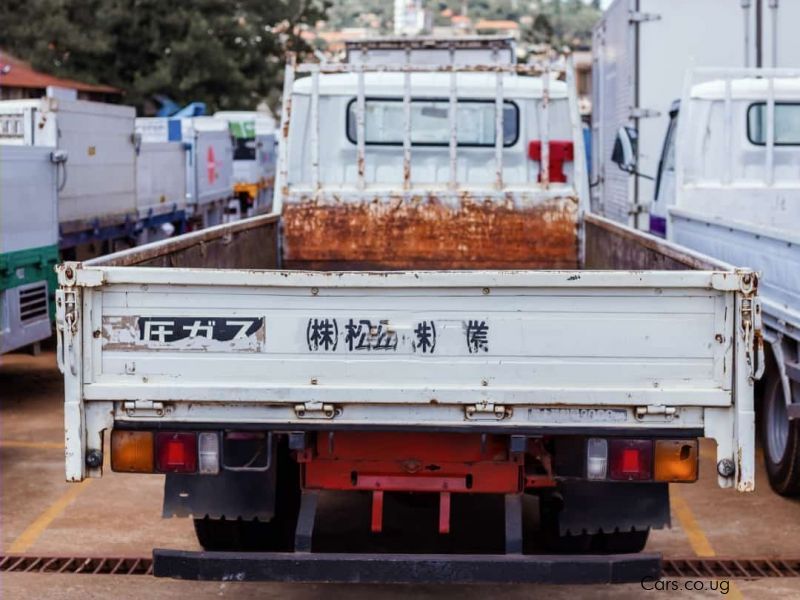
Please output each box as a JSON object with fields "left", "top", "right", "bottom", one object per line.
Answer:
{"left": 0, "top": 554, "right": 153, "bottom": 575}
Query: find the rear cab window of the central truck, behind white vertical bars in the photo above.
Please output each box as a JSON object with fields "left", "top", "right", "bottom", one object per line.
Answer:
{"left": 347, "top": 98, "right": 519, "bottom": 147}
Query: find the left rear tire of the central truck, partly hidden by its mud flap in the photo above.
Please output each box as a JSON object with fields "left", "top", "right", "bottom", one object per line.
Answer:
{"left": 194, "top": 438, "right": 300, "bottom": 552}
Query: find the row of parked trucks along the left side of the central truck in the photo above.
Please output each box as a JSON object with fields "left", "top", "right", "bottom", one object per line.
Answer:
{"left": 0, "top": 97, "right": 275, "bottom": 353}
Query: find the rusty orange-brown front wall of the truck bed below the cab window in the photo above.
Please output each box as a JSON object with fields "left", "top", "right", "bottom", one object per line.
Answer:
{"left": 283, "top": 196, "right": 578, "bottom": 270}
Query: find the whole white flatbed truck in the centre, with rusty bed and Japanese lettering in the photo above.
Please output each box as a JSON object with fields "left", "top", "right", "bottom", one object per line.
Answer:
{"left": 58, "top": 49, "right": 762, "bottom": 583}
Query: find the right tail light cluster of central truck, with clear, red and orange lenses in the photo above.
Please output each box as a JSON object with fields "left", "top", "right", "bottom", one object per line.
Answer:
{"left": 586, "top": 438, "right": 698, "bottom": 482}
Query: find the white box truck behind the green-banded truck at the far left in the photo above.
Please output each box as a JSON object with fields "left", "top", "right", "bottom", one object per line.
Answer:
{"left": 0, "top": 97, "right": 137, "bottom": 256}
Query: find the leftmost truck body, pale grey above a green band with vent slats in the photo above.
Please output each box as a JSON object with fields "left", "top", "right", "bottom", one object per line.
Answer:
{"left": 0, "top": 145, "right": 58, "bottom": 354}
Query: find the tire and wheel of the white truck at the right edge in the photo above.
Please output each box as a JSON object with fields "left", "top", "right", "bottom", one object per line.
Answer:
{"left": 761, "top": 371, "right": 800, "bottom": 496}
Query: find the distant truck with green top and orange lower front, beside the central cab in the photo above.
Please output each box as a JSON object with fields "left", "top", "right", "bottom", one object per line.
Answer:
{"left": 214, "top": 111, "right": 277, "bottom": 216}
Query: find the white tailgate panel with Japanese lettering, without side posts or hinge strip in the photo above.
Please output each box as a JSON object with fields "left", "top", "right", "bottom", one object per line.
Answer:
{"left": 84, "top": 273, "right": 733, "bottom": 406}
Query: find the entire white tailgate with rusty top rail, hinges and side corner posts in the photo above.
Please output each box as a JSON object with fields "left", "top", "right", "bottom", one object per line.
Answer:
{"left": 59, "top": 263, "right": 752, "bottom": 488}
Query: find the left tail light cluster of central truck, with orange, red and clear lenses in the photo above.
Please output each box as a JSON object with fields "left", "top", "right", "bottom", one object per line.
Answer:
{"left": 111, "top": 429, "right": 220, "bottom": 475}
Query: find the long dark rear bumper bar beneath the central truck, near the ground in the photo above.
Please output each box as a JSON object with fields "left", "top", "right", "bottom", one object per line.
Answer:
{"left": 153, "top": 548, "right": 661, "bottom": 584}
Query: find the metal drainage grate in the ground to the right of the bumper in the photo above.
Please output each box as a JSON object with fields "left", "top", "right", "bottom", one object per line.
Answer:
{"left": 661, "top": 558, "right": 800, "bottom": 579}
